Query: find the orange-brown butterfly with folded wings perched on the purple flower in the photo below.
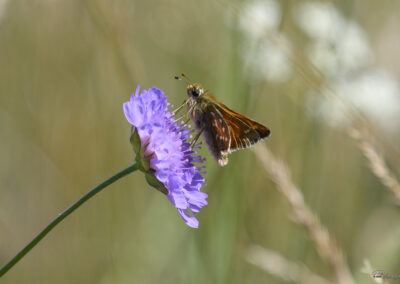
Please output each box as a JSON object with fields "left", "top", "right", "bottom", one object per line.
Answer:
{"left": 175, "top": 73, "right": 271, "bottom": 166}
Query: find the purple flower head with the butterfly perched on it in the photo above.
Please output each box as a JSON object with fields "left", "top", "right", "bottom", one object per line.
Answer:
{"left": 124, "top": 87, "right": 207, "bottom": 228}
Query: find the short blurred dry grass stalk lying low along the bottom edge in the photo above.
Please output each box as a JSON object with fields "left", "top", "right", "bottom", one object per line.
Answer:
{"left": 245, "top": 245, "right": 332, "bottom": 284}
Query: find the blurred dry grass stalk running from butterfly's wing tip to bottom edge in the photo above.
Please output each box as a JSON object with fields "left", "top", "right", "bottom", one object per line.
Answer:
{"left": 253, "top": 145, "right": 354, "bottom": 284}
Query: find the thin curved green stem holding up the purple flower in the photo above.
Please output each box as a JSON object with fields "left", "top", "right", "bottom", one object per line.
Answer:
{"left": 0, "top": 163, "right": 138, "bottom": 277}
